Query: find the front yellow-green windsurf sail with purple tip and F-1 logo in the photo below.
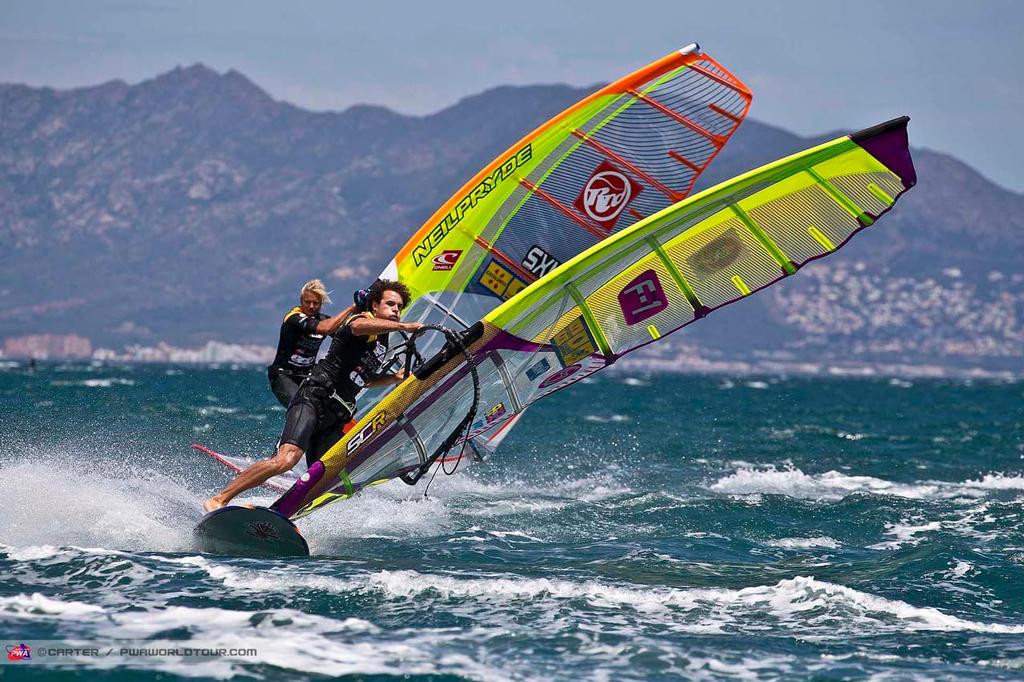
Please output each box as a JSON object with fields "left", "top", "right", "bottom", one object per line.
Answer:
{"left": 274, "top": 117, "right": 916, "bottom": 517}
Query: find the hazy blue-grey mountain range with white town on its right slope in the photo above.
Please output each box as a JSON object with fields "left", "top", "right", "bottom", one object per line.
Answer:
{"left": 0, "top": 65, "right": 1024, "bottom": 371}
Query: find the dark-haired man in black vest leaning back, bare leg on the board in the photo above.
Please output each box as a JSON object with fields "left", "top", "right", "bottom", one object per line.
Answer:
{"left": 203, "top": 280, "right": 422, "bottom": 512}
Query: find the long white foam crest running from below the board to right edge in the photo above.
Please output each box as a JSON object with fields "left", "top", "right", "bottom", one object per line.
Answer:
{"left": 159, "top": 557, "right": 1024, "bottom": 638}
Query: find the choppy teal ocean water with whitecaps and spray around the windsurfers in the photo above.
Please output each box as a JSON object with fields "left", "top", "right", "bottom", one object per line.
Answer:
{"left": 0, "top": 364, "right": 1024, "bottom": 681}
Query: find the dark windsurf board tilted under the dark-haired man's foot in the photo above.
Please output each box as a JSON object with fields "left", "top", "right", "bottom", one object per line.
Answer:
{"left": 193, "top": 507, "right": 309, "bottom": 558}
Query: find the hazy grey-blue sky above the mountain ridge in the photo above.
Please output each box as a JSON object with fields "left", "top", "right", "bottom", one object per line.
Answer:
{"left": 0, "top": 0, "right": 1024, "bottom": 191}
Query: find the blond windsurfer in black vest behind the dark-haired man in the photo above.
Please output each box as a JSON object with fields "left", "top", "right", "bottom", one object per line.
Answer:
{"left": 266, "top": 280, "right": 355, "bottom": 408}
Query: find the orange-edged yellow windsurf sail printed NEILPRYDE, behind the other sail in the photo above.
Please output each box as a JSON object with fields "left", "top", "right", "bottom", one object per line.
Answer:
{"left": 357, "top": 43, "right": 751, "bottom": 436}
